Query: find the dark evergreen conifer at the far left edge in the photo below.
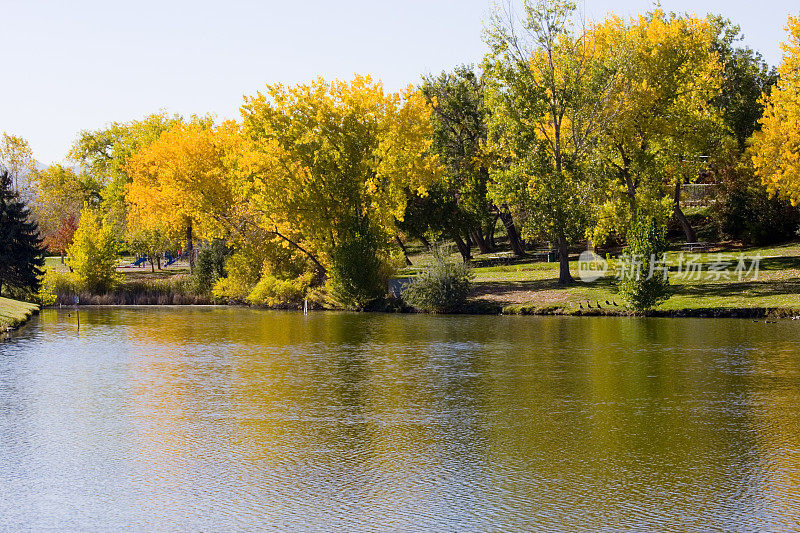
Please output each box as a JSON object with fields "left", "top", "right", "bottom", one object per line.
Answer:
{"left": 0, "top": 171, "right": 44, "bottom": 295}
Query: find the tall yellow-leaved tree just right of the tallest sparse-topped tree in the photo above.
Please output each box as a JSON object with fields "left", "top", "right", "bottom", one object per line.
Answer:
{"left": 592, "top": 9, "right": 724, "bottom": 241}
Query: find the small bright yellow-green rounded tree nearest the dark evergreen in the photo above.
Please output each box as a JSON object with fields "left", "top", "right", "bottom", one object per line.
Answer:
{"left": 67, "top": 207, "right": 120, "bottom": 293}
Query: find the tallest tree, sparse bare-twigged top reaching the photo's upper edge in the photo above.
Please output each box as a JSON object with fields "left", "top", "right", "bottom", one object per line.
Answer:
{"left": 484, "top": 0, "right": 619, "bottom": 284}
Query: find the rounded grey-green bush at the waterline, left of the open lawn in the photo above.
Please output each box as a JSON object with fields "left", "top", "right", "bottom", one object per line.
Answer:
{"left": 403, "top": 247, "right": 472, "bottom": 313}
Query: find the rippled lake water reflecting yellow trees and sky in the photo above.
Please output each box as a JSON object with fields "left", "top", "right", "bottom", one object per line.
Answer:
{"left": 0, "top": 307, "right": 800, "bottom": 531}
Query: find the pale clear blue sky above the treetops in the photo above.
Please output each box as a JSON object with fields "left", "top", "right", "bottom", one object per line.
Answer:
{"left": 0, "top": 0, "right": 800, "bottom": 163}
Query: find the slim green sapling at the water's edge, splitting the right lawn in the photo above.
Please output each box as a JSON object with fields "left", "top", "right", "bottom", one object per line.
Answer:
{"left": 618, "top": 211, "right": 670, "bottom": 311}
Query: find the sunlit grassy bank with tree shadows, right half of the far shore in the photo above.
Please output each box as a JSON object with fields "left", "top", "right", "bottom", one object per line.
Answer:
{"left": 407, "top": 242, "right": 800, "bottom": 317}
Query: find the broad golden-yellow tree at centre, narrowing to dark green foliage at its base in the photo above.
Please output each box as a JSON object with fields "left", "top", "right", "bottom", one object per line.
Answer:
{"left": 239, "top": 76, "right": 440, "bottom": 307}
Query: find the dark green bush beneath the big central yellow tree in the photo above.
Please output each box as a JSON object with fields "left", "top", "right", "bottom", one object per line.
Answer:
{"left": 328, "top": 228, "right": 389, "bottom": 309}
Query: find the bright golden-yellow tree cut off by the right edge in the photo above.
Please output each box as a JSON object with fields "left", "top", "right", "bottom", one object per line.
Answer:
{"left": 750, "top": 13, "right": 800, "bottom": 205}
